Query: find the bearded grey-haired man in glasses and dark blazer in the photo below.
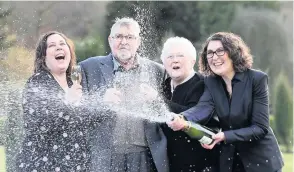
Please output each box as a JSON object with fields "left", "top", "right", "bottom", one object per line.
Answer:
{"left": 80, "top": 18, "right": 169, "bottom": 172}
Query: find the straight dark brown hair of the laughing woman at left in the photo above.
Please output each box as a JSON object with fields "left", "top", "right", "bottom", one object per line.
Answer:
{"left": 34, "top": 31, "right": 76, "bottom": 76}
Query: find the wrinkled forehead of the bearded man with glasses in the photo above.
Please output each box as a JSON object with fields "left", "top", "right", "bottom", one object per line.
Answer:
{"left": 110, "top": 24, "right": 140, "bottom": 37}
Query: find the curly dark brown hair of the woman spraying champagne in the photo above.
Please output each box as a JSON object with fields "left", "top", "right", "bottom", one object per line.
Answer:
{"left": 198, "top": 32, "right": 253, "bottom": 75}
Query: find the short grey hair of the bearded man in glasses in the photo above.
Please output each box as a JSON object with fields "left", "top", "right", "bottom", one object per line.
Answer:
{"left": 110, "top": 17, "right": 140, "bottom": 36}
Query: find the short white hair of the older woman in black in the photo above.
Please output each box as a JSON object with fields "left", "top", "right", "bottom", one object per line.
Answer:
{"left": 160, "top": 36, "right": 197, "bottom": 61}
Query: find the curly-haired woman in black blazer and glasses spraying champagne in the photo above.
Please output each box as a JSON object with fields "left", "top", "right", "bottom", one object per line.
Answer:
{"left": 168, "top": 32, "right": 284, "bottom": 172}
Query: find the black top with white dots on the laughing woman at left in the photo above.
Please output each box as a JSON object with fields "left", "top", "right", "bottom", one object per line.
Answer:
{"left": 16, "top": 71, "right": 93, "bottom": 172}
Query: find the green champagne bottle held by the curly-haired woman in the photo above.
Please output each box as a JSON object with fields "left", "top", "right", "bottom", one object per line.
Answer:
{"left": 184, "top": 121, "right": 218, "bottom": 145}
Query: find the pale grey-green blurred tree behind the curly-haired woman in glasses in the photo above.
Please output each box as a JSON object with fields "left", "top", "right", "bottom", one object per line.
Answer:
{"left": 231, "top": 7, "right": 293, "bottom": 107}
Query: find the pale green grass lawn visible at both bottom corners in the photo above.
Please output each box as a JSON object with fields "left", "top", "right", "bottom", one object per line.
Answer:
{"left": 0, "top": 146, "right": 293, "bottom": 172}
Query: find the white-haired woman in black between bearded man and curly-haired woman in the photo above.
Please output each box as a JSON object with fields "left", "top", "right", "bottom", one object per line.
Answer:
{"left": 161, "top": 37, "right": 218, "bottom": 172}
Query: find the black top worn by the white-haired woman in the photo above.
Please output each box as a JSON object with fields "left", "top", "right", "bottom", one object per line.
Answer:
{"left": 163, "top": 74, "right": 218, "bottom": 172}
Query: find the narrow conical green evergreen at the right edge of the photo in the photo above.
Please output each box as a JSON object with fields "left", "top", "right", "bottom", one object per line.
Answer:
{"left": 274, "top": 73, "right": 293, "bottom": 152}
